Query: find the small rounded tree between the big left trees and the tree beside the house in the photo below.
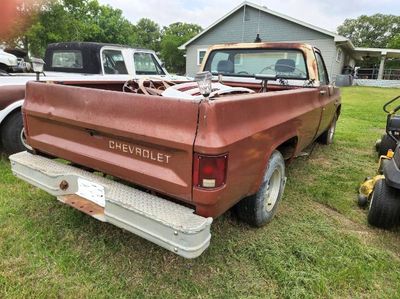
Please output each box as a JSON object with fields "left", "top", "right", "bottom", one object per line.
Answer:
{"left": 136, "top": 18, "right": 161, "bottom": 52}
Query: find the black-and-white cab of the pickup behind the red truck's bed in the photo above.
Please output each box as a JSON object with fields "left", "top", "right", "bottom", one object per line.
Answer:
{"left": 44, "top": 42, "right": 170, "bottom": 79}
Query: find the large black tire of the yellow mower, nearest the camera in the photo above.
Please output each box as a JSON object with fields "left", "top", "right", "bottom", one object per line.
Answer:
{"left": 368, "top": 179, "right": 400, "bottom": 229}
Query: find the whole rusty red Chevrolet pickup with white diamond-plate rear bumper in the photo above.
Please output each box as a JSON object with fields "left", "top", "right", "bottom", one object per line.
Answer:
{"left": 10, "top": 43, "right": 341, "bottom": 258}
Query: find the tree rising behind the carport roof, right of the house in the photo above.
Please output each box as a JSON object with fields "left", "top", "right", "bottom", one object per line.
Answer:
{"left": 338, "top": 14, "right": 400, "bottom": 48}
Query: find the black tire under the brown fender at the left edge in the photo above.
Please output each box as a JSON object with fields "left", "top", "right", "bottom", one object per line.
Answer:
{"left": 1, "top": 111, "right": 26, "bottom": 155}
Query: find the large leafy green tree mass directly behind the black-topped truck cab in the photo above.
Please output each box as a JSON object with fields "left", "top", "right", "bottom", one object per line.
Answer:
{"left": 4, "top": 0, "right": 136, "bottom": 56}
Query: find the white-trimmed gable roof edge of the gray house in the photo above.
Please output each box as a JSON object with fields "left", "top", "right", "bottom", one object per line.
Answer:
{"left": 179, "top": 1, "right": 354, "bottom": 50}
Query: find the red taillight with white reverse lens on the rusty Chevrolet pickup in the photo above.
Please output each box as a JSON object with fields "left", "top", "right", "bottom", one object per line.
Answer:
{"left": 193, "top": 154, "right": 228, "bottom": 189}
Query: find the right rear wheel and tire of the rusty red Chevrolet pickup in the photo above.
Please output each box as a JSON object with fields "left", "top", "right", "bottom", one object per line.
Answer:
{"left": 235, "top": 151, "right": 286, "bottom": 227}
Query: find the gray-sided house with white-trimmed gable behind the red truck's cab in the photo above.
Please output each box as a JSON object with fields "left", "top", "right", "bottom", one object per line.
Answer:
{"left": 179, "top": 2, "right": 361, "bottom": 78}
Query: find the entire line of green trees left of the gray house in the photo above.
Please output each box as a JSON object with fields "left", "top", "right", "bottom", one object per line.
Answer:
{"left": 0, "top": 0, "right": 202, "bottom": 73}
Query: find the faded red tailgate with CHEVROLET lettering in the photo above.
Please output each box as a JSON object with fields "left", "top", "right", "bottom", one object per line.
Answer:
{"left": 23, "top": 82, "right": 199, "bottom": 201}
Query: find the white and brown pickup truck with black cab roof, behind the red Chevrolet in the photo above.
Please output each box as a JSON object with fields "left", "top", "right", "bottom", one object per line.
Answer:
{"left": 0, "top": 42, "right": 187, "bottom": 154}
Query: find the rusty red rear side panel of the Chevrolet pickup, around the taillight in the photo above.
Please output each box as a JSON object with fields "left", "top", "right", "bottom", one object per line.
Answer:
{"left": 193, "top": 88, "right": 322, "bottom": 216}
